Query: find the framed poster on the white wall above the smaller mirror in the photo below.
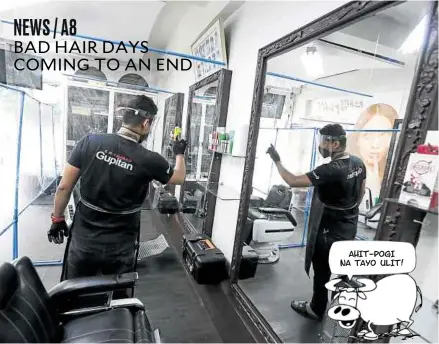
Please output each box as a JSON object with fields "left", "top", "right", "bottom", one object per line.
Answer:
{"left": 191, "top": 19, "right": 227, "bottom": 81}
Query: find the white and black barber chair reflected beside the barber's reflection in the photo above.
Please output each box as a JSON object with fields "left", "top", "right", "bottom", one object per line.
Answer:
{"left": 244, "top": 185, "right": 297, "bottom": 264}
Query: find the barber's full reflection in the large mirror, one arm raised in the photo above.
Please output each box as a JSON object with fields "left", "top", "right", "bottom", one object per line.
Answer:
{"left": 267, "top": 124, "right": 366, "bottom": 320}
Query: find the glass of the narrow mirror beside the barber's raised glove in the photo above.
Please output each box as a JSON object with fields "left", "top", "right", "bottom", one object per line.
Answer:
{"left": 183, "top": 81, "right": 219, "bottom": 232}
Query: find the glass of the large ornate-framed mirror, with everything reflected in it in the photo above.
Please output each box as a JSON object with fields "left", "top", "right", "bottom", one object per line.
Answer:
{"left": 238, "top": 2, "right": 435, "bottom": 342}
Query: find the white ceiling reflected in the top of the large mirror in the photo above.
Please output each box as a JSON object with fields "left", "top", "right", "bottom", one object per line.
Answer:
{"left": 267, "top": 2, "right": 430, "bottom": 92}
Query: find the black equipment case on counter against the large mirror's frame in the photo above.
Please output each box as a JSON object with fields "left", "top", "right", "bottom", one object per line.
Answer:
{"left": 183, "top": 234, "right": 227, "bottom": 284}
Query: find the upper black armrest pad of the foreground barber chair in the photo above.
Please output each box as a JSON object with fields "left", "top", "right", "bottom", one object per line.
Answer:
{"left": 49, "top": 272, "right": 139, "bottom": 300}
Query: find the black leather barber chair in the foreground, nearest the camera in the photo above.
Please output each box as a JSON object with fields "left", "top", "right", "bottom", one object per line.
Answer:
{"left": 0, "top": 257, "right": 160, "bottom": 343}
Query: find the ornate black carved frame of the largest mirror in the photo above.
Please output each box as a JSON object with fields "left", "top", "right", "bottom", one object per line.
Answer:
{"left": 230, "top": 1, "right": 438, "bottom": 342}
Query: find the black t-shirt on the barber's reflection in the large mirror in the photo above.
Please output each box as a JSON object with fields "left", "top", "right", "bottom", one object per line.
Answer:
{"left": 306, "top": 155, "right": 366, "bottom": 222}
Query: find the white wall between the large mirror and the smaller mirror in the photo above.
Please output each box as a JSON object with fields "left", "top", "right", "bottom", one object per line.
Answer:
{"left": 213, "top": 1, "right": 344, "bottom": 261}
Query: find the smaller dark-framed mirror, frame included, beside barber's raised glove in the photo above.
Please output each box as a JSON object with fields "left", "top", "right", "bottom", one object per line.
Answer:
{"left": 180, "top": 69, "right": 232, "bottom": 235}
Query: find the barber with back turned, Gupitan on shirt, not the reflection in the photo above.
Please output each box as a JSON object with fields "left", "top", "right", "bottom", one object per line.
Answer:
{"left": 48, "top": 95, "right": 186, "bottom": 279}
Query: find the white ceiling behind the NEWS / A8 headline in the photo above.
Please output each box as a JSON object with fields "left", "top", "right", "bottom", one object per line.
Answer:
{"left": 0, "top": 0, "right": 201, "bottom": 61}
